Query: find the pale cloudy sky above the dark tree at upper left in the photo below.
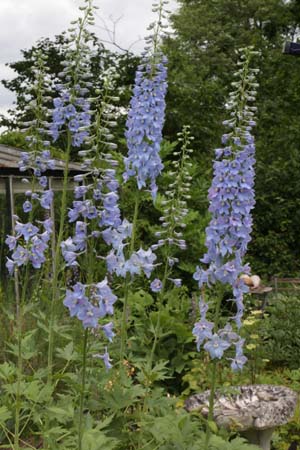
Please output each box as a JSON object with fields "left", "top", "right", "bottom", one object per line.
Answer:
{"left": 0, "top": 0, "right": 177, "bottom": 119}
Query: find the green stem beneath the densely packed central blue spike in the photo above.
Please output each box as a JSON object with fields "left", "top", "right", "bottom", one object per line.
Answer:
{"left": 120, "top": 193, "right": 139, "bottom": 361}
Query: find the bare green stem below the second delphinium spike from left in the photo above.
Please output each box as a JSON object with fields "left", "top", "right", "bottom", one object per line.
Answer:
{"left": 48, "top": 132, "right": 72, "bottom": 384}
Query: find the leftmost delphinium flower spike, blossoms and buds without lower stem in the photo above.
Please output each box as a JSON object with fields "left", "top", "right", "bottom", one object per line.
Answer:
{"left": 6, "top": 51, "right": 55, "bottom": 274}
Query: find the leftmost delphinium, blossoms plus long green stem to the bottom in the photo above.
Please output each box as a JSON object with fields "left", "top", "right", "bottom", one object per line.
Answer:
{"left": 6, "top": 51, "right": 54, "bottom": 449}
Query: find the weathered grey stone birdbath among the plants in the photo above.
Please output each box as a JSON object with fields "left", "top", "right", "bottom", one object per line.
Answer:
{"left": 185, "top": 384, "right": 298, "bottom": 450}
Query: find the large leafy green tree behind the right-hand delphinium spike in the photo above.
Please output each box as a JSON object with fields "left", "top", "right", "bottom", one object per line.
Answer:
{"left": 165, "top": 0, "right": 300, "bottom": 276}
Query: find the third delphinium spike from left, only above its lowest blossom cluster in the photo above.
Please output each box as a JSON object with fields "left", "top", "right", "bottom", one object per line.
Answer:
{"left": 62, "top": 78, "right": 122, "bottom": 272}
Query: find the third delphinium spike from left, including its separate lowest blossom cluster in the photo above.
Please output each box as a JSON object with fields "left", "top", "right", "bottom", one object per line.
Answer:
{"left": 61, "top": 69, "right": 122, "bottom": 367}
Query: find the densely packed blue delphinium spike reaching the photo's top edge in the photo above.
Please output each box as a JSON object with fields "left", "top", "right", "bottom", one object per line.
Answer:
{"left": 123, "top": 0, "right": 167, "bottom": 199}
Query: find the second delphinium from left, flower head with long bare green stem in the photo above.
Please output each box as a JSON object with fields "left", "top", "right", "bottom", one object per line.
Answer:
{"left": 48, "top": 0, "right": 95, "bottom": 383}
